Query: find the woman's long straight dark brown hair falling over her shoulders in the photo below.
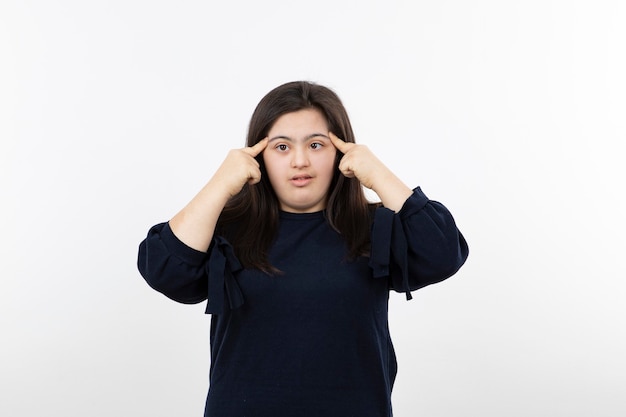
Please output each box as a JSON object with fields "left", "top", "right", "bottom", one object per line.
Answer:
{"left": 216, "top": 81, "right": 372, "bottom": 273}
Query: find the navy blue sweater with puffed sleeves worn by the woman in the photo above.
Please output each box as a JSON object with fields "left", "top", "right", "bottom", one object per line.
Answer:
{"left": 138, "top": 188, "right": 468, "bottom": 417}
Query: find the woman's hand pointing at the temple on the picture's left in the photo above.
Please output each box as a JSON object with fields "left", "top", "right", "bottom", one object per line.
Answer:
{"left": 213, "top": 138, "right": 268, "bottom": 197}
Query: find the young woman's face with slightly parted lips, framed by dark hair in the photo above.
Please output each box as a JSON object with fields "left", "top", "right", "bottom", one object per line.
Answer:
{"left": 263, "top": 109, "right": 337, "bottom": 213}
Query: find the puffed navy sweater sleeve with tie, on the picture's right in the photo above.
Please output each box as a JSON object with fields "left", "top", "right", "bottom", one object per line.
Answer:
{"left": 370, "top": 187, "right": 469, "bottom": 299}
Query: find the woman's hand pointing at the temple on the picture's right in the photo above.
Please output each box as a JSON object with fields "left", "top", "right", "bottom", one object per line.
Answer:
{"left": 328, "top": 132, "right": 387, "bottom": 189}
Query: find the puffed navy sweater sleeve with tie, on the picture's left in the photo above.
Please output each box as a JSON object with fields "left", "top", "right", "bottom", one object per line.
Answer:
{"left": 137, "top": 223, "right": 243, "bottom": 313}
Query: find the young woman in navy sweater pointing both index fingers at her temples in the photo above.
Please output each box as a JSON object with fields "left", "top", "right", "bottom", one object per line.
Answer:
{"left": 138, "top": 82, "right": 468, "bottom": 417}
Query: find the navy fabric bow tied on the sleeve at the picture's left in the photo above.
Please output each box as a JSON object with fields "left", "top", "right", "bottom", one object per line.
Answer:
{"left": 205, "top": 236, "right": 244, "bottom": 314}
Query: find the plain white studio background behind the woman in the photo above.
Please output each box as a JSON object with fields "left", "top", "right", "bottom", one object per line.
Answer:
{"left": 0, "top": 0, "right": 626, "bottom": 417}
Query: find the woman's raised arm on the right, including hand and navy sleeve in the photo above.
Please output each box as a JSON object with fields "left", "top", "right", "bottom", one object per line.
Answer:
{"left": 329, "top": 133, "right": 469, "bottom": 292}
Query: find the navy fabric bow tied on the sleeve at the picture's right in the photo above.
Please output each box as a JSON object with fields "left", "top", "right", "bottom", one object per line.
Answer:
{"left": 369, "top": 207, "right": 413, "bottom": 300}
